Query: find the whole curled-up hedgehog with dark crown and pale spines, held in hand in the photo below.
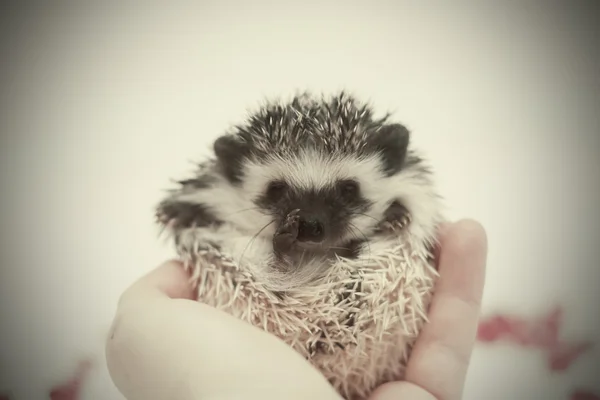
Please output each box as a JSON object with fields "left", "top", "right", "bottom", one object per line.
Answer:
{"left": 157, "top": 93, "right": 442, "bottom": 400}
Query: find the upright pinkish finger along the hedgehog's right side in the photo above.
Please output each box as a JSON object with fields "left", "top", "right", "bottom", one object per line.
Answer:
{"left": 406, "top": 220, "right": 487, "bottom": 400}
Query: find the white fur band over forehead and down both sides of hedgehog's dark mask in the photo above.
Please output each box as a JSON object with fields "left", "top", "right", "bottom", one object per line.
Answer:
{"left": 166, "top": 147, "right": 441, "bottom": 276}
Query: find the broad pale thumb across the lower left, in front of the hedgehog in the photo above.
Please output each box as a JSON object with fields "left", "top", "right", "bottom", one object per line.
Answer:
{"left": 106, "top": 260, "right": 340, "bottom": 400}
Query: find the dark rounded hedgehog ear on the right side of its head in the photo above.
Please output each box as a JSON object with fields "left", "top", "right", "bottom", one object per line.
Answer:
{"left": 372, "top": 124, "right": 410, "bottom": 176}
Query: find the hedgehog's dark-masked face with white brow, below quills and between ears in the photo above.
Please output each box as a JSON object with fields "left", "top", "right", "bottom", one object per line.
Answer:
{"left": 244, "top": 151, "right": 381, "bottom": 248}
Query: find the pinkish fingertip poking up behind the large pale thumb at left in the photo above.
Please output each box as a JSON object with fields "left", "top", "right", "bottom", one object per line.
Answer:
{"left": 119, "top": 260, "right": 196, "bottom": 307}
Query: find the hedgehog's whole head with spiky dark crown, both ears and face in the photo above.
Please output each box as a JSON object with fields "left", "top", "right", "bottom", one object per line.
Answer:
{"left": 214, "top": 96, "right": 418, "bottom": 256}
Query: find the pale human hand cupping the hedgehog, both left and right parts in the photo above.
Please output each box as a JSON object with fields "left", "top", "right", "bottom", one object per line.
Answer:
{"left": 106, "top": 220, "right": 487, "bottom": 400}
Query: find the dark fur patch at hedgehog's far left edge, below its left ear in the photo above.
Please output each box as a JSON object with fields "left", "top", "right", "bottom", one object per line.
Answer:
{"left": 157, "top": 201, "right": 222, "bottom": 229}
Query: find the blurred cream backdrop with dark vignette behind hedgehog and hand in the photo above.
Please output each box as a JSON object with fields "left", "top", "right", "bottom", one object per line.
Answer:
{"left": 0, "top": 1, "right": 600, "bottom": 400}
